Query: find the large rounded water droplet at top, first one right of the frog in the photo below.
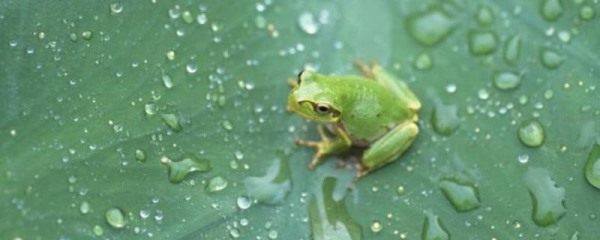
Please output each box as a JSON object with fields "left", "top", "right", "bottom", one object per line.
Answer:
{"left": 406, "top": 7, "right": 456, "bottom": 46}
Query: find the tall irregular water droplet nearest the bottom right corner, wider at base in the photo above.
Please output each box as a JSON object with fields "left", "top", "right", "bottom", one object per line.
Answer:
{"left": 525, "top": 168, "right": 567, "bottom": 227}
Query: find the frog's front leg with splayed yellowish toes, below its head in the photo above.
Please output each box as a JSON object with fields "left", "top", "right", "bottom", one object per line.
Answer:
{"left": 296, "top": 124, "right": 352, "bottom": 169}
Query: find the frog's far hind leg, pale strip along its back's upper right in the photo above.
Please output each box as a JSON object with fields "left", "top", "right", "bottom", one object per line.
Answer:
{"left": 371, "top": 64, "right": 421, "bottom": 112}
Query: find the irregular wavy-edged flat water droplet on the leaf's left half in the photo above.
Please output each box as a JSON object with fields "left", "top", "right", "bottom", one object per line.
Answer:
{"left": 160, "top": 154, "right": 210, "bottom": 183}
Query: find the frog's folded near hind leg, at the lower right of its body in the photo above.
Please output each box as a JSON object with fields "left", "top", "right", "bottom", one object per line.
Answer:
{"left": 361, "top": 122, "right": 419, "bottom": 175}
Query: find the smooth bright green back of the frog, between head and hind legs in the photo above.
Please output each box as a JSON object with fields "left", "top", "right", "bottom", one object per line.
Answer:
{"left": 324, "top": 76, "right": 414, "bottom": 142}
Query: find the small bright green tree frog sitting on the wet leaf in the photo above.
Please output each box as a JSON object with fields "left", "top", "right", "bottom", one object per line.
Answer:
{"left": 287, "top": 61, "right": 421, "bottom": 179}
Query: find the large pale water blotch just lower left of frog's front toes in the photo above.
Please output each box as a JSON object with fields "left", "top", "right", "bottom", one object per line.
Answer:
{"left": 244, "top": 159, "right": 292, "bottom": 204}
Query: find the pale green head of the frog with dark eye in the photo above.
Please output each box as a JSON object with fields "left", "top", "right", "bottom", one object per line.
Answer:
{"left": 288, "top": 70, "right": 340, "bottom": 123}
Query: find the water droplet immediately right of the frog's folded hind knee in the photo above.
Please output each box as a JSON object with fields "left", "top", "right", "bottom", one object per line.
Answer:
{"left": 431, "top": 101, "right": 460, "bottom": 136}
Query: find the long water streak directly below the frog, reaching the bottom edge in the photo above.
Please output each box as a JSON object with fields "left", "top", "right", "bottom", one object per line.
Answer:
{"left": 308, "top": 177, "right": 362, "bottom": 240}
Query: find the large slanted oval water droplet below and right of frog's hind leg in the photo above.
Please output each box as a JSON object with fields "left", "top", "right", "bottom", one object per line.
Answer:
{"left": 440, "top": 178, "right": 481, "bottom": 212}
